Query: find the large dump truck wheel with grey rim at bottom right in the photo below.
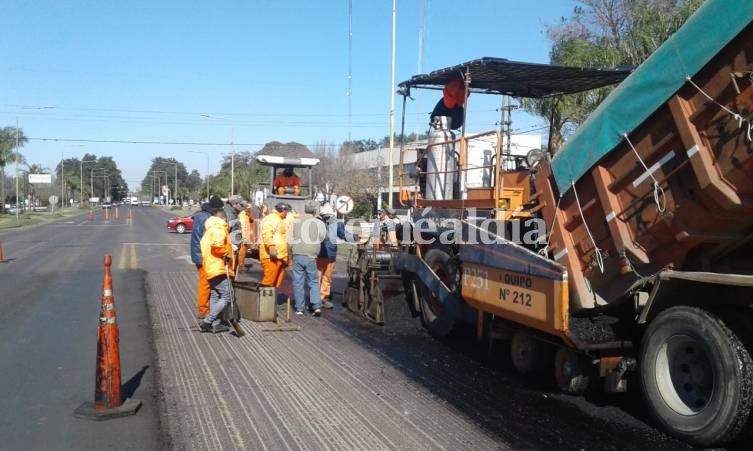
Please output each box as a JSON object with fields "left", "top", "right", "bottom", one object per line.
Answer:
{"left": 640, "top": 306, "right": 753, "bottom": 446}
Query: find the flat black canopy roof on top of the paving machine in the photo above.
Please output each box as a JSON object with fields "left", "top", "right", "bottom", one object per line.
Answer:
{"left": 399, "top": 57, "right": 630, "bottom": 98}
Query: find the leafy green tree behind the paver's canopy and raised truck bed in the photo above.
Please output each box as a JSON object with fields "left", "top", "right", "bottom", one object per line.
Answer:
{"left": 522, "top": 0, "right": 703, "bottom": 153}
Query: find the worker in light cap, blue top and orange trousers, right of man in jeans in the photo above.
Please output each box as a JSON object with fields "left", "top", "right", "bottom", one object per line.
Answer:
{"left": 316, "top": 203, "right": 358, "bottom": 309}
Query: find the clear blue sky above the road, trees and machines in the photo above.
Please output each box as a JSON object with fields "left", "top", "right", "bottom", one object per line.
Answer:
{"left": 0, "top": 0, "right": 575, "bottom": 187}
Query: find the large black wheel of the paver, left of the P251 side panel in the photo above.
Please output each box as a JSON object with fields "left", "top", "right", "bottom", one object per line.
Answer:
{"left": 416, "top": 248, "right": 458, "bottom": 337}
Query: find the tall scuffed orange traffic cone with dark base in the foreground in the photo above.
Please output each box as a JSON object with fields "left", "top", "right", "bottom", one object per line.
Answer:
{"left": 73, "top": 254, "right": 141, "bottom": 420}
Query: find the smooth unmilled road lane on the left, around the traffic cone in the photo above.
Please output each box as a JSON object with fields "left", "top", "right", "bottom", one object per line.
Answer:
{"left": 0, "top": 209, "right": 164, "bottom": 450}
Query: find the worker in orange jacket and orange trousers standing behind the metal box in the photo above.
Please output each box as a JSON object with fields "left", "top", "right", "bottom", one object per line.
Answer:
{"left": 259, "top": 202, "right": 293, "bottom": 287}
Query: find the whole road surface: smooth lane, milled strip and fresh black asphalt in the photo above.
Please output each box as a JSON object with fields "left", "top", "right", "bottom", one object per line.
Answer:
{"left": 0, "top": 208, "right": 728, "bottom": 450}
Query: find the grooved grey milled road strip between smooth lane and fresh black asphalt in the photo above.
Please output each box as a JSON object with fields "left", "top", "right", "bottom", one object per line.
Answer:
{"left": 147, "top": 273, "right": 506, "bottom": 450}
